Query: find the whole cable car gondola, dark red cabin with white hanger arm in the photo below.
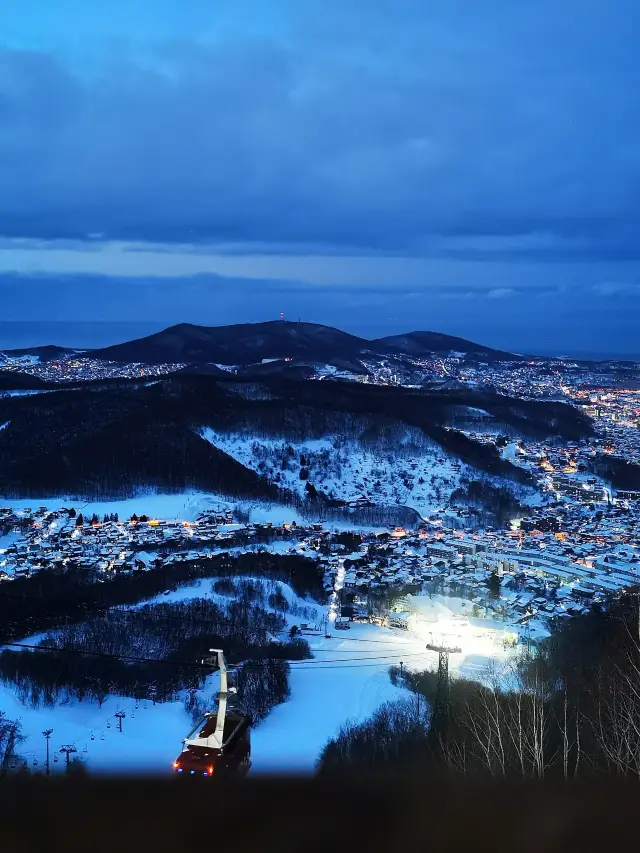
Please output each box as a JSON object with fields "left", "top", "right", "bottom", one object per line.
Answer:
{"left": 172, "top": 649, "right": 251, "bottom": 778}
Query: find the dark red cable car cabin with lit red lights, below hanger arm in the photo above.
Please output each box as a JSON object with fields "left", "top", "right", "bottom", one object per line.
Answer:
{"left": 173, "top": 711, "right": 251, "bottom": 779}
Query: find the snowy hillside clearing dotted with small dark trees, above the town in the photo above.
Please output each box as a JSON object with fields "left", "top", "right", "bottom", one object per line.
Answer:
{"left": 200, "top": 427, "right": 472, "bottom": 515}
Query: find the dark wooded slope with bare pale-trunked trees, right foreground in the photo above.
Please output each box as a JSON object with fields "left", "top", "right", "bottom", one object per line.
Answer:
{"left": 321, "top": 592, "right": 640, "bottom": 783}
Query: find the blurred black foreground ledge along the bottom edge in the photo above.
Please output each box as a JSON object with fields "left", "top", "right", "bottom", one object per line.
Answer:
{"left": 0, "top": 777, "right": 640, "bottom": 853}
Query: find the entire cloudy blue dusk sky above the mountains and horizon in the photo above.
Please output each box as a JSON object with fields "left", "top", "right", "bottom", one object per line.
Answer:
{"left": 0, "top": 0, "right": 640, "bottom": 355}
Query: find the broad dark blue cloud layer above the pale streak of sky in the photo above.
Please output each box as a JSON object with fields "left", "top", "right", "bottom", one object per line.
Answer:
{"left": 0, "top": 0, "right": 640, "bottom": 260}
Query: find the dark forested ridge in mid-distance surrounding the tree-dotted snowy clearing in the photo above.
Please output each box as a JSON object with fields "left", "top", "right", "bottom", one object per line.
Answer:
{"left": 0, "top": 375, "right": 589, "bottom": 503}
